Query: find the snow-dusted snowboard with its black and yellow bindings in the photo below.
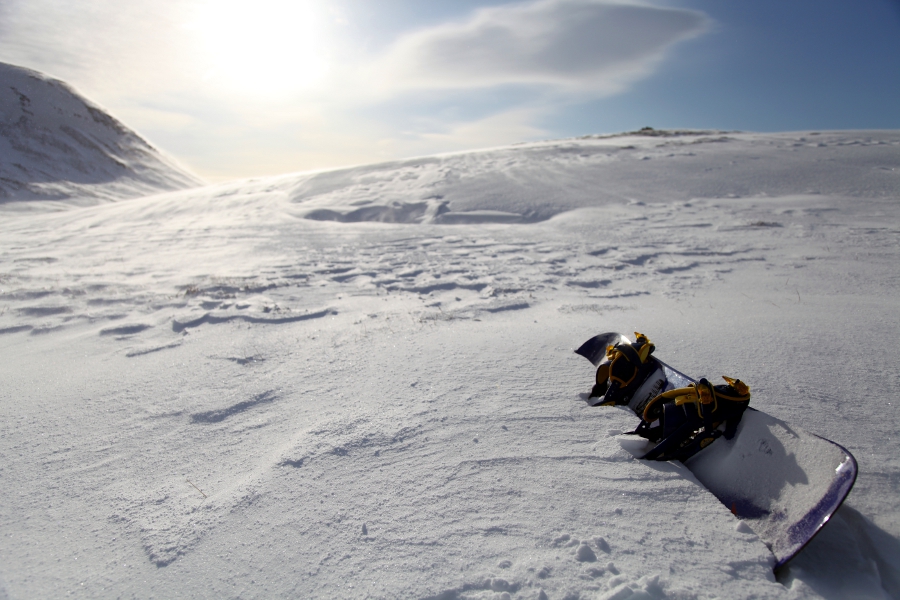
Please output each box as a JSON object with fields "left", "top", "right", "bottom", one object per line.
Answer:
{"left": 575, "top": 332, "right": 859, "bottom": 570}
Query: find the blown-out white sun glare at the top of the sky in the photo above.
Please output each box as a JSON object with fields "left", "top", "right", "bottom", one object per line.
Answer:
{"left": 192, "top": 0, "right": 327, "bottom": 99}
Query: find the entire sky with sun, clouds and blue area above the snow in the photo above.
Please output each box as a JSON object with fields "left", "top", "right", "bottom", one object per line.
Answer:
{"left": 0, "top": 0, "right": 900, "bottom": 181}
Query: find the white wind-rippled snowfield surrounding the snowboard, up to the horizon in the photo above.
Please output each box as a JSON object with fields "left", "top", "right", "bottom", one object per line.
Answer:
{"left": 0, "top": 72, "right": 900, "bottom": 600}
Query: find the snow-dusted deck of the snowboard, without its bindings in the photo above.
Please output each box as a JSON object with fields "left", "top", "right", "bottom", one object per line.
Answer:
{"left": 575, "top": 333, "right": 858, "bottom": 570}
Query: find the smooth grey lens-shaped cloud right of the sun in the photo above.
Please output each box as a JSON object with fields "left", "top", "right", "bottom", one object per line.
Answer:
{"left": 379, "top": 0, "right": 708, "bottom": 95}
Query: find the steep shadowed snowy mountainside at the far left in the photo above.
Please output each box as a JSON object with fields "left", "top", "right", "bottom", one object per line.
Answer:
{"left": 0, "top": 63, "right": 201, "bottom": 204}
